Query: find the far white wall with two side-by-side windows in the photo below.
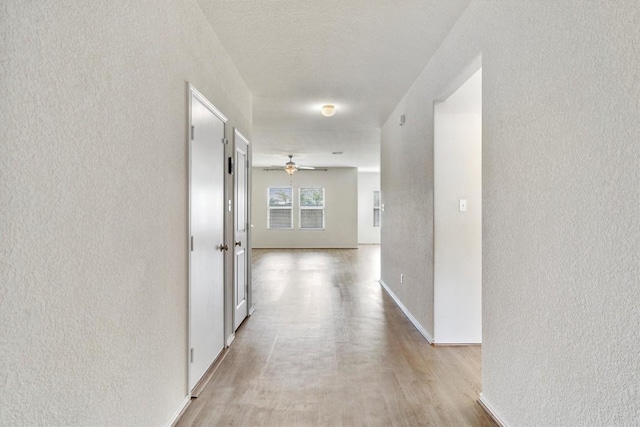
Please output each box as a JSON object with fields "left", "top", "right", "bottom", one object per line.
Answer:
{"left": 251, "top": 168, "right": 358, "bottom": 248}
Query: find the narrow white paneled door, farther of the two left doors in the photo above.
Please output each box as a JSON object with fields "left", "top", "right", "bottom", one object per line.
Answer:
{"left": 233, "top": 131, "right": 249, "bottom": 330}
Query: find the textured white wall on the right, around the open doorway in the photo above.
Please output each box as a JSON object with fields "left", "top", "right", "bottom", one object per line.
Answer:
{"left": 381, "top": 0, "right": 640, "bottom": 426}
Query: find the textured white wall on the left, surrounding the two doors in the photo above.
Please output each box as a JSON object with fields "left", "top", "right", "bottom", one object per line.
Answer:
{"left": 0, "top": 0, "right": 251, "bottom": 426}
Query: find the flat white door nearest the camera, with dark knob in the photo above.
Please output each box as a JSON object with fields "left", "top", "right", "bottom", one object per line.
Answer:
{"left": 189, "top": 88, "right": 225, "bottom": 390}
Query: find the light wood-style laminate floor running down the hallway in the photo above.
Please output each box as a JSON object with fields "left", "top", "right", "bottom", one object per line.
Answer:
{"left": 178, "top": 246, "right": 494, "bottom": 426}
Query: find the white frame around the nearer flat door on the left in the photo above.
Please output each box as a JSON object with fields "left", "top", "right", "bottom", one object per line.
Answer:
{"left": 185, "top": 82, "right": 228, "bottom": 397}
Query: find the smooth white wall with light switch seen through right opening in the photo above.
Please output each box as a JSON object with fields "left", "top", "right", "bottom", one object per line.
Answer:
{"left": 433, "top": 71, "right": 482, "bottom": 343}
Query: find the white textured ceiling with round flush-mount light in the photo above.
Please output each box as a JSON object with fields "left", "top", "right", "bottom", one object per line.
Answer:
{"left": 198, "top": 0, "right": 470, "bottom": 170}
